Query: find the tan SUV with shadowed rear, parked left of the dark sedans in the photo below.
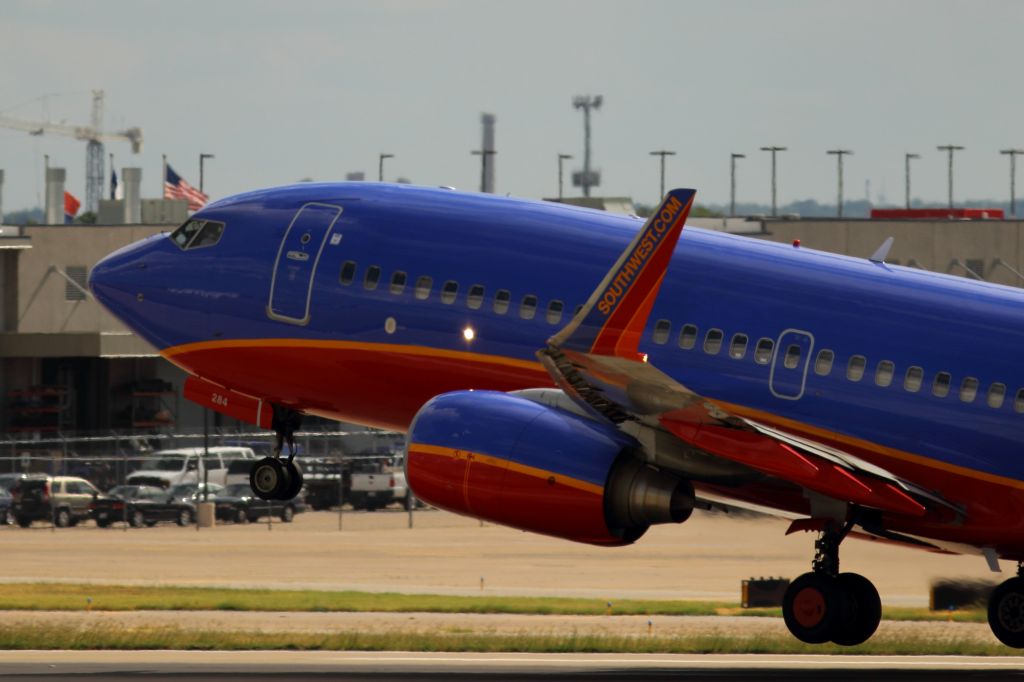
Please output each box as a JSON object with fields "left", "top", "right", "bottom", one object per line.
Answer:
{"left": 10, "top": 475, "right": 99, "bottom": 528}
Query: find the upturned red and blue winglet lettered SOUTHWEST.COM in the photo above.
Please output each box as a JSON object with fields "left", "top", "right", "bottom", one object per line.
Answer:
{"left": 549, "top": 189, "right": 696, "bottom": 359}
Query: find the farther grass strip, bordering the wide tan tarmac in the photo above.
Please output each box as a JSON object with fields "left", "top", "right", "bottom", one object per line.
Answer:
{"left": 0, "top": 583, "right": 986, "bottom": 623}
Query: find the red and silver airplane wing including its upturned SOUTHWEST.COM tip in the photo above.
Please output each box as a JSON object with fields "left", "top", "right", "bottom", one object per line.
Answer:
{"left": 538, "top": 189, "right": 959, "bottom": 517}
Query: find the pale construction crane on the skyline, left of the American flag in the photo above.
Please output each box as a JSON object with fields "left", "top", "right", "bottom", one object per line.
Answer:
{"left": 0, "top": 90, "right": 142, "bottom": 213}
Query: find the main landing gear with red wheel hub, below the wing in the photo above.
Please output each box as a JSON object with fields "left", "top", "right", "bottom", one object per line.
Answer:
{"left": 782, "top": 521, "right": 880, "bottom": 646}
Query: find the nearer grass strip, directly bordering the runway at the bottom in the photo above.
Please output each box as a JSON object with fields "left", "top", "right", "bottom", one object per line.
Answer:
{"left": 0, "top": 624, "right": 1017, "bottom": 655}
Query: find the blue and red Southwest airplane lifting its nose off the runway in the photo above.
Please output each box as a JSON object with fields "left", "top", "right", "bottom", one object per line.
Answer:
{"left": 90, "top": 182, "right": 1024, "bottom": 648}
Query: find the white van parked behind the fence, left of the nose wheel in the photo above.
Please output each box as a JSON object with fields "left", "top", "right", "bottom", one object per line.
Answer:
{"left": 127, "top": 445, "right": 256, "bottom": 487}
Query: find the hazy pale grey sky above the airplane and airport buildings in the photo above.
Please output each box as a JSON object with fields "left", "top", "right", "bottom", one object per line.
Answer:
{"left": 0, "top": 0, "right": 1024, "bottom": 211}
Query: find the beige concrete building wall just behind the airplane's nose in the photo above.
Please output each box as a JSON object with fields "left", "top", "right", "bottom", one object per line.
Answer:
{"left": 11, "top": 225, "right": 173, "bottom": 334}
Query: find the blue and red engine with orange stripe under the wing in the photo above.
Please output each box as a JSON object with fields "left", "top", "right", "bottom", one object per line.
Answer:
{"left": 406, "top": 391, "right": 693, "bottom": 545}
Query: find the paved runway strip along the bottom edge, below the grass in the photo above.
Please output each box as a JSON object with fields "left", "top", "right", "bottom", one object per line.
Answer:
{"left": 0, "top": 651, "right": 1024, "bottom": 682}
